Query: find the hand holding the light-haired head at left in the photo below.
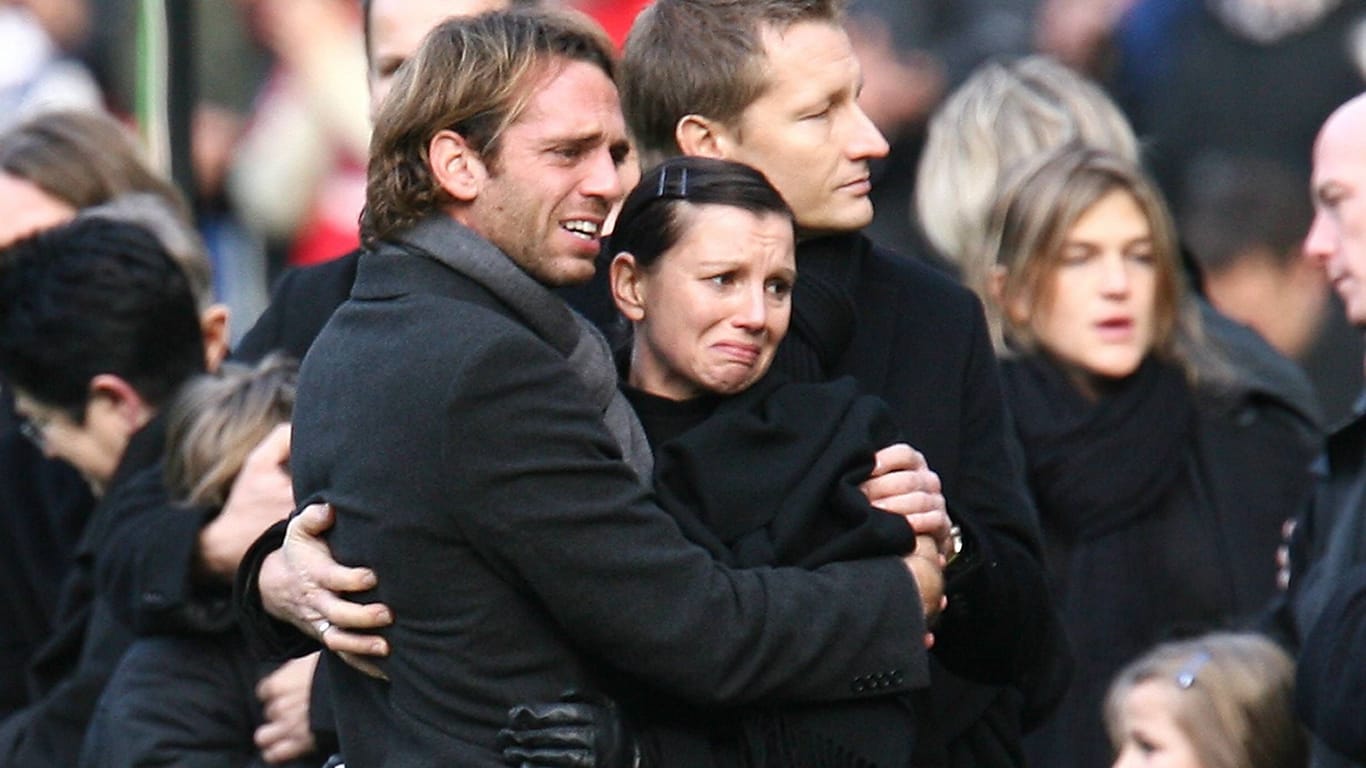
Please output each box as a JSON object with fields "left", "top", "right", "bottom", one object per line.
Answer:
{"left": 198, "top": 424, "right": 294, "bottom": 582}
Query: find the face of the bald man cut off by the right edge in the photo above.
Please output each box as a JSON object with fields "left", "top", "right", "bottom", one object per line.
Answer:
{"left": 1305, "top": 97, "right": 1366, "bottom": 328}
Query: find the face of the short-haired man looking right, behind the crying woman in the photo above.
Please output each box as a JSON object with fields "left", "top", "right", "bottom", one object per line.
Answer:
{"left": 725, "top": 22, "right": 888, "bottom": 236}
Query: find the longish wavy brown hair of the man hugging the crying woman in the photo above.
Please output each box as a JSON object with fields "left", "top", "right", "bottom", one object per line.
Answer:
{"left": 361, "top": 8, "right": 616, "bottom": 245}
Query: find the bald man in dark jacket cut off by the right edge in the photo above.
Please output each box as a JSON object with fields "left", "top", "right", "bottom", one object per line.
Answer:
{"left": 1280, "top": 94, "right": 1366, "bottom": 765}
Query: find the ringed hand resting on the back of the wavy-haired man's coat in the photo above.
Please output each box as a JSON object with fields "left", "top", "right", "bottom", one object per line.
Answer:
{"left": 260, "top": 504, "right": 393, "bottom": 676}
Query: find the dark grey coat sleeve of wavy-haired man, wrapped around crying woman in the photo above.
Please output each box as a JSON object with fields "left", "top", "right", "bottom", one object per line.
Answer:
{"left": 439, "top": 336, "right": 928, "bottom": 705}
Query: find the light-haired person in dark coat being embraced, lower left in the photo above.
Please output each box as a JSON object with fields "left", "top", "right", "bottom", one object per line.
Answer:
{"left": 81, "top": 355, "right": 322, "bottom": 768}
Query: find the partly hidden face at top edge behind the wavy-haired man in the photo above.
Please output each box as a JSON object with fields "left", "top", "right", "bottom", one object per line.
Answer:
{"left": 367, "top": 0, "right": 508, "bottom": 120}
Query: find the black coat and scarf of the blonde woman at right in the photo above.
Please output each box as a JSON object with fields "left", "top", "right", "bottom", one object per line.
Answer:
{"left": 1003, "top": 357, "right": 1314, "bottom": 767}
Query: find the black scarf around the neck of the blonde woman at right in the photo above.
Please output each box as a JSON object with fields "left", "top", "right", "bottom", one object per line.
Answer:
{"left": 1001, "top": 357, "right": 1195, "bottom": 541}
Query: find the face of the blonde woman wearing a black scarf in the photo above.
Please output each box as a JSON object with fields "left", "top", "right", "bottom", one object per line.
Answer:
{"left": 1007, "top": 190, "right": 1160, "bottom": 379}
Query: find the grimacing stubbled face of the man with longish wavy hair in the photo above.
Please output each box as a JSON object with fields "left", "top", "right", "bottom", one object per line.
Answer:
{"left": 462, "top": 61, "right": 635, "bottom": 286}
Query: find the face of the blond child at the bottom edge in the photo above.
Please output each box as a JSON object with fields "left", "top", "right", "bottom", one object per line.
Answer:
{"left": 1113, "top": 681, "right": 1202, "bottom": 768}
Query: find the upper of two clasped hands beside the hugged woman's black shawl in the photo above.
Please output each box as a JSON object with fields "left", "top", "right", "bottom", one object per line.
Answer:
{"left": 859, "top": 443, "right": 953, "bottom": 558}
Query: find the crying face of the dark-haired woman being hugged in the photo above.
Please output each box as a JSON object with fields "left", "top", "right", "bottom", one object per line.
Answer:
{"left": 612, "top": 205, "right": 796, "bottom": 400}
